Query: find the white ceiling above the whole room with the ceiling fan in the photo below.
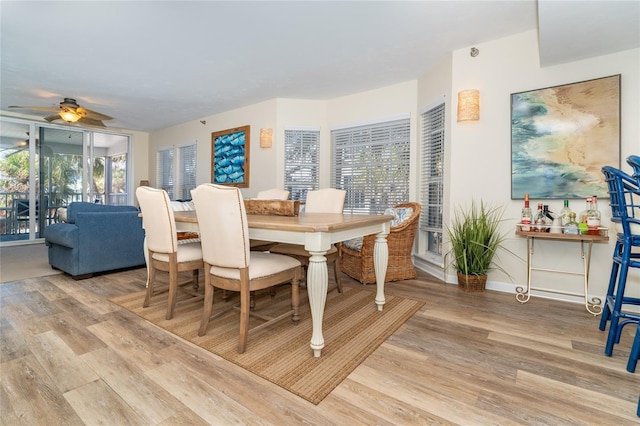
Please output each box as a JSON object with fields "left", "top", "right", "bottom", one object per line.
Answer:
{"left": 0, "top": 0, "right": 640, "bottom": 131}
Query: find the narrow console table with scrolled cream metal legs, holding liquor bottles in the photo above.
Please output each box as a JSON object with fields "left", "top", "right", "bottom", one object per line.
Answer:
{"left": 516, "top": 229, "right": 609, "bottom": 315}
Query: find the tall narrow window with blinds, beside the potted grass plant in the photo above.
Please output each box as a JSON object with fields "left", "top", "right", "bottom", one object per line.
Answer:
{"left": 420, "top": 103, "right": 445, "bottom": 256}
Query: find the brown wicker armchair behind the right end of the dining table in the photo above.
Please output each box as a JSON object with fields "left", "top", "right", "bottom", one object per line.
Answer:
{"left": 340, "top": 202, "right": 421, "bottom": 284}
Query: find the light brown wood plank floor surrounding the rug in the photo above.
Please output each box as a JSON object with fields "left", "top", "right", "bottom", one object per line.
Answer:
{"left": 0, "top": 269, "right": 640, "bottom": 425}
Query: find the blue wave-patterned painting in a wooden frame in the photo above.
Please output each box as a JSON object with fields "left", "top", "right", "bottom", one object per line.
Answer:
{"left": 211, "top": 126, "right": 250, "bottom": 188}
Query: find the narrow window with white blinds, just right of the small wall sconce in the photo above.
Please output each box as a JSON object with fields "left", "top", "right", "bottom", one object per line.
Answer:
{"left": 284, "top": 129, "right": 320, "bottom": 201}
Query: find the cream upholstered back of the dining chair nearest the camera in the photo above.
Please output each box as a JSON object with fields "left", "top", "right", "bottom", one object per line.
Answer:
{"left": 191, "top": 183, "right": 249, "bottom": 269}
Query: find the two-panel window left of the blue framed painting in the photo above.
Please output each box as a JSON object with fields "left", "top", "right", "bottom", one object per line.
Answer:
{"left": 156, "top": 143, "right": 197, "bottom": 200}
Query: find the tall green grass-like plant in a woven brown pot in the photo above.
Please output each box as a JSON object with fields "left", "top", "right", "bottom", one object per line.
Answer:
{"left": 447, "top": 201, "right": 505, "bottom": 291}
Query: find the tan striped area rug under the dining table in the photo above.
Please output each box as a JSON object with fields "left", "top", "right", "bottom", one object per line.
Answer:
{"left": 110, "top": 286, "right": 423, "bottom": 404}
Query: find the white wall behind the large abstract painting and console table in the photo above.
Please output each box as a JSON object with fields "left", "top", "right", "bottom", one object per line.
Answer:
{"left": 446, "top": 31, "right": 640, "bottom": 302}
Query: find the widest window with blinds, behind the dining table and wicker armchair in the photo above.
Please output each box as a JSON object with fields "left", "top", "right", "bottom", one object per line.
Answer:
{"left": 331, "top": 117, "right": 410, "bottom": 214}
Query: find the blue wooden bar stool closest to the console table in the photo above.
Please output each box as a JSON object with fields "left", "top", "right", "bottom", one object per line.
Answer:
{"left": 600, "top": 166, "right": 640, "bottom": 356}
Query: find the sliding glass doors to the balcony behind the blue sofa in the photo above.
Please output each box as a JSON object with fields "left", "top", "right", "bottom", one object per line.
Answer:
{"left": 0, "top": 117, "right": 133, "bottom": 245}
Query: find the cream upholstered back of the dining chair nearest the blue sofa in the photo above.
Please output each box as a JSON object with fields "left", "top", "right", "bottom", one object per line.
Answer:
{"left": 136, "top": 186, "right": 178, "bottom": 253}
